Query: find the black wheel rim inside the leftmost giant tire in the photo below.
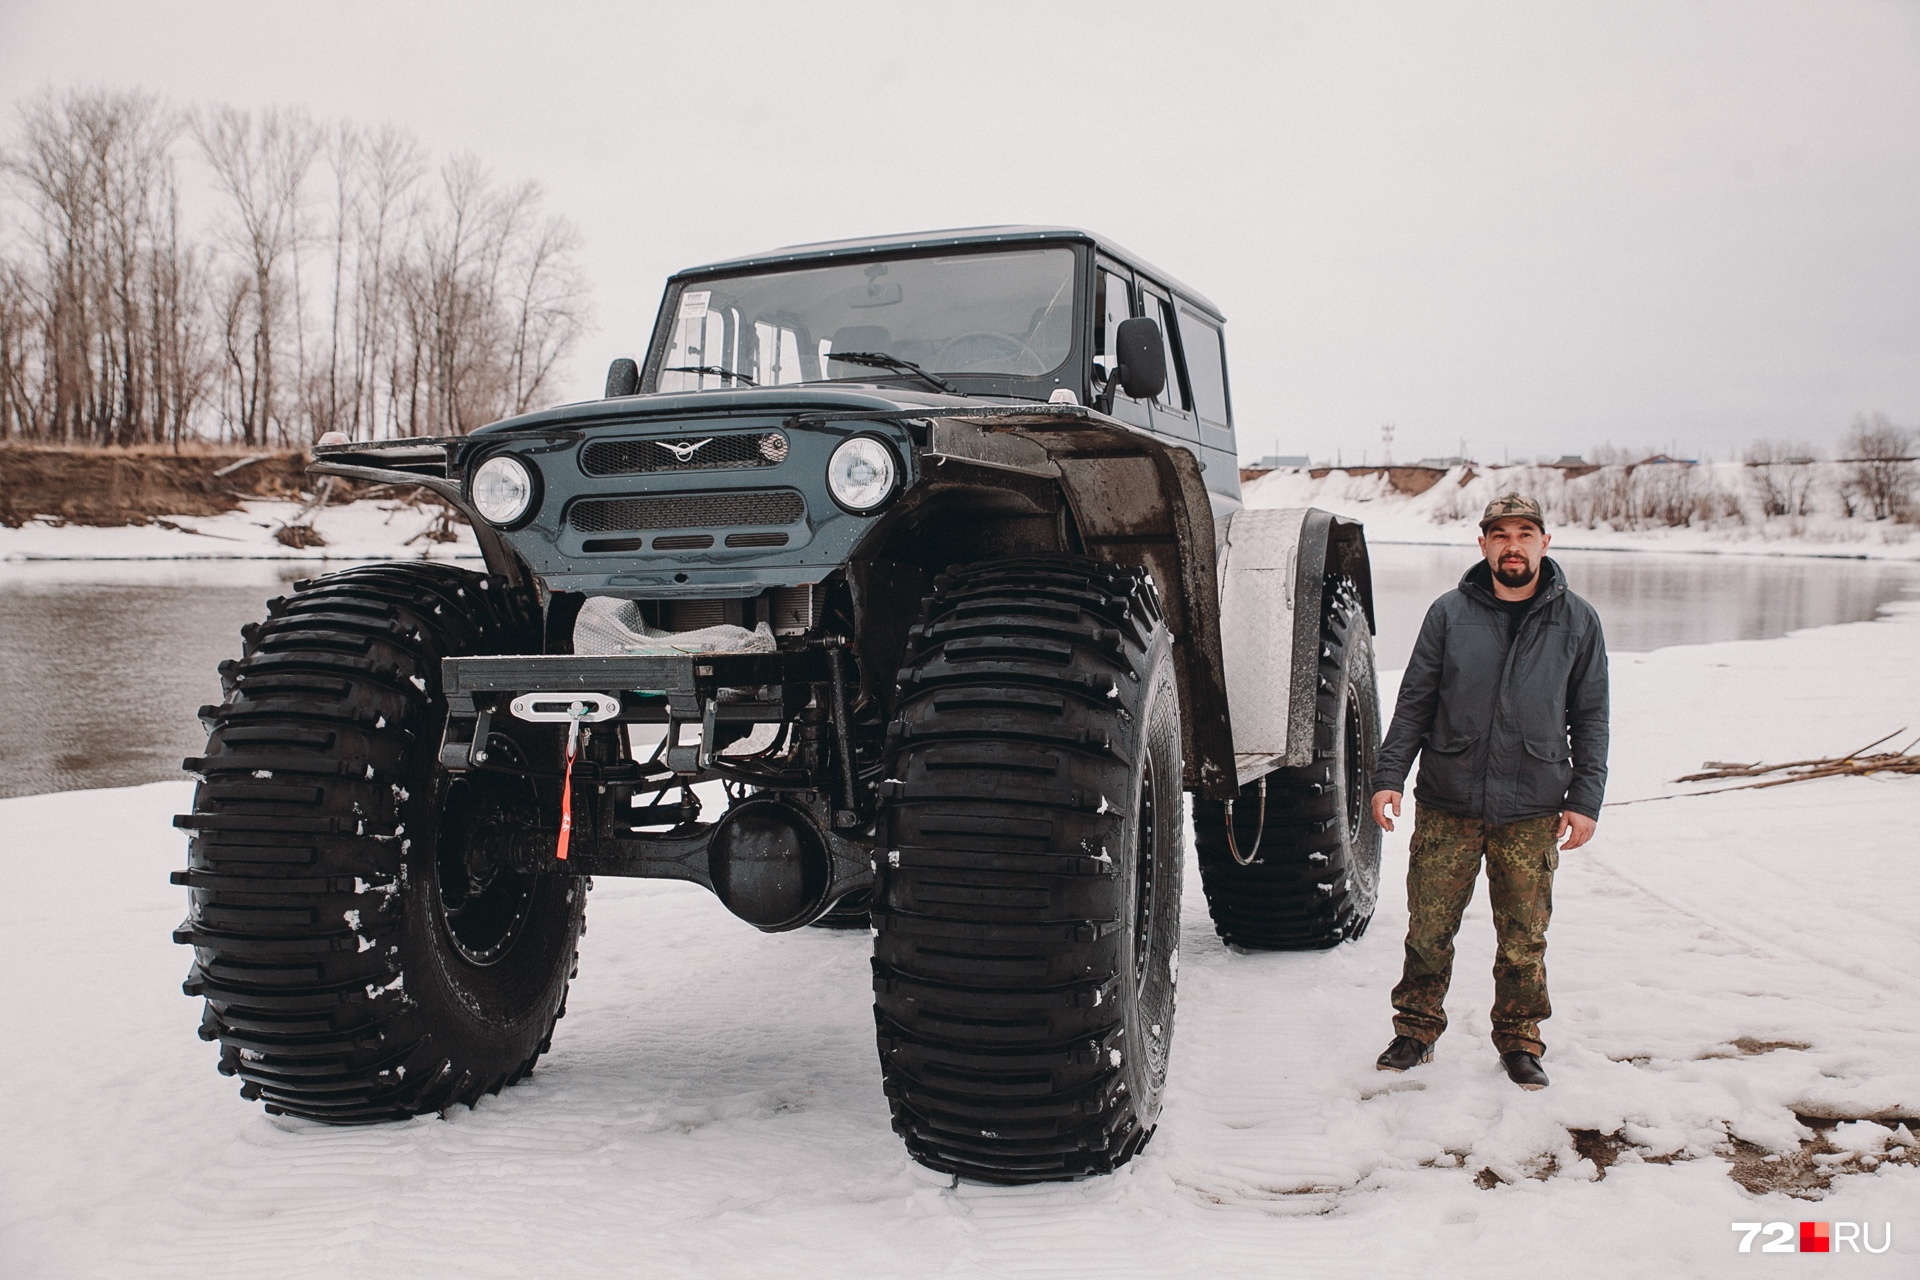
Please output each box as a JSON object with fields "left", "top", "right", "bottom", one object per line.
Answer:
{"left": 434, "top": 743, "right": 534, "bottom": 965}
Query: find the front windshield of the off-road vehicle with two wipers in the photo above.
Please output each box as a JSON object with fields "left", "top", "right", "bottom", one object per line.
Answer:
{"left": 655, "top": 248, "right": 1073, "bottom": 391}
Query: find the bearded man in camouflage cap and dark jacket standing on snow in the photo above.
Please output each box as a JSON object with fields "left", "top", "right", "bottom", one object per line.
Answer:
{"left": 1373, "top": 493, "right": 1607, "bottom": 1088}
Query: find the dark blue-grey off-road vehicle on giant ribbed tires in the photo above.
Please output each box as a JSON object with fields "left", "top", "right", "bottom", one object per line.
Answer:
{"left": 175, "top": 226, "right": 1379, "bottom": 1182}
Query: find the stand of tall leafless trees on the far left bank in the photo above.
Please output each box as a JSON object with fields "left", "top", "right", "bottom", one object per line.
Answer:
{"left": 0, "top": 92, "right": 586, "bottom": 445}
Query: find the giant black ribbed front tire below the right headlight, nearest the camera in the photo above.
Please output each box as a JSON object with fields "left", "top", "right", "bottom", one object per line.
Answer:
{"left": 874, "top": 557, "right": 1183, "bottom": 1182}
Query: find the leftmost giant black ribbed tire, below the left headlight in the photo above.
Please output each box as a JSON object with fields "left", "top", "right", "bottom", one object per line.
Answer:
{"left": 175, "top": 564, "right": 588, "bottom": 1123}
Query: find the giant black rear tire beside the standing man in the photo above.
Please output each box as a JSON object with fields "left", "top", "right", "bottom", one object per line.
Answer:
{"left": 1194, "top": 578, "right": 1380, "bottom": 950}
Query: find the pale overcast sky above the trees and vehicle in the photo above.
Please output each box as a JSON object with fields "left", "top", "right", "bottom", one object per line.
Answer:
{"left": 0, "top": 0, "right": 1920, "bottom": 461}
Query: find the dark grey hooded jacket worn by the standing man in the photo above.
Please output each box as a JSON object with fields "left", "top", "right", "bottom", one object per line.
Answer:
{"left": 1373, "top": 557, "right": 1607, "bottom": 823}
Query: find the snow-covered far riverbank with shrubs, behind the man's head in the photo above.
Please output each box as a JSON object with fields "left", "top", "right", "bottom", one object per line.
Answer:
{"left": 1244, "top": 462, "right": 1920, "bottom": 560}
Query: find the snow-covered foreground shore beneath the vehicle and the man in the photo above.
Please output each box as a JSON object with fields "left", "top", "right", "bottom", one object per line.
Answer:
{"left": 0, "top": 604, "right": 1920, "bottom": 1280}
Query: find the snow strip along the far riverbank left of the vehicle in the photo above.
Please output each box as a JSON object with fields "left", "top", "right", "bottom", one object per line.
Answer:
{"left": 0, "top": 499, "right": 480, "bottom": 562}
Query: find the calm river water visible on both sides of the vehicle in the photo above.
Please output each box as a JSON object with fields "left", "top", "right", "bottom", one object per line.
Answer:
{"left": 0, "top": 543, "right": 1920, "bottom": 796}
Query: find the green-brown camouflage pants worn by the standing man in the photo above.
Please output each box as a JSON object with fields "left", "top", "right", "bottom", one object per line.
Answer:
{"left": 1394, "top": 808, "right": 1559, "bottom": 1054}
